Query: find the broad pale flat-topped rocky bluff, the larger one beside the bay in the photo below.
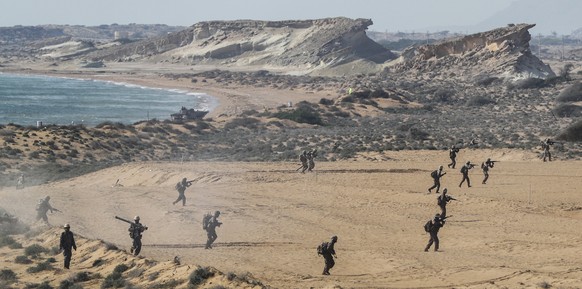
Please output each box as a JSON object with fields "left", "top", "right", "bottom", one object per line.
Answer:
{"left": 85, "top": 18, "right": 397, "bottom": 72}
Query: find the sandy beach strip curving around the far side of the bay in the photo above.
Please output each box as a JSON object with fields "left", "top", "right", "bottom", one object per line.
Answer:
{"left": 0, "top": 65, "right": 336, "bottom": 119}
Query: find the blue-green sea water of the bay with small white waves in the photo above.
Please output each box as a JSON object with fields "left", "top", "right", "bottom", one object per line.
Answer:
{"left": 0, "top": 73, "right": 218, "bottom": 126}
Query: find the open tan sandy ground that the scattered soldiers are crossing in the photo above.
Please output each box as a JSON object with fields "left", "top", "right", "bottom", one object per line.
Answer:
{"left": 0, "top": 150, "right": 582, "bottom": 288}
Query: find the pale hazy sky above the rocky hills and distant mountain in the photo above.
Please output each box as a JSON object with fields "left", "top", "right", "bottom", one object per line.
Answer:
{"left": 0, "top": 0, "right": 513, "bottom": 32}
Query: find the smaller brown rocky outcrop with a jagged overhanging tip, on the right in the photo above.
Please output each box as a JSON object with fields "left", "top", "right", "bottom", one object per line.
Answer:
{"left": 392, "top": 24, "right": 555, "bottom": 80}
